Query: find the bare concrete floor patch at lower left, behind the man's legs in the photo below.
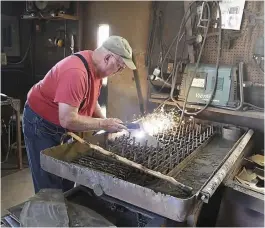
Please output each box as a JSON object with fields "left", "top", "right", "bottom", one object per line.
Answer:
{"left": 1, "top": 168, "right": 34, "bottom": 216}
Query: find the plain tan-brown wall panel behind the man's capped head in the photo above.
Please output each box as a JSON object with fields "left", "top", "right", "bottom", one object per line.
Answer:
{"left": 83, "top": 2, "right": 151, "bottom": 121}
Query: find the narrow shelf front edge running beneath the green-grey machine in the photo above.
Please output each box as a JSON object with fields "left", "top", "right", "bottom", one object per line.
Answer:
{"left": 149, "top": 98, "right": 264, "bottom": 120}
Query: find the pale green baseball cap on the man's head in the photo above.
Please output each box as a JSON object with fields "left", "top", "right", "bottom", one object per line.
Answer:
{"left": 102, "top": 36, "right": 136, "bottom": 70}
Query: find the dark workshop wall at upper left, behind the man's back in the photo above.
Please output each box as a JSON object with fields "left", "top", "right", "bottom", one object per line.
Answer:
{"left": 1, "top": 1, "right": 78, "bottom": 107}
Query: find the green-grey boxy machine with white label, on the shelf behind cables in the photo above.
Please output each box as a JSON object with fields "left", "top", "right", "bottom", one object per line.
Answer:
{"left": 178, "top": 64, "right": 239, "bottom": 107}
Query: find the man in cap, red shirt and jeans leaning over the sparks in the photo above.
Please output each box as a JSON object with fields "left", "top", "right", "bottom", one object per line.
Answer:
{"left": 23, "top": 36, "right": 136, "bottom": 193}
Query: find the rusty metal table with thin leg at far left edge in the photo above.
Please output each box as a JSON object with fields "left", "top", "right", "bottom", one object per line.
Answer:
{"left": 1, "top": 99, "right": 23, "bottom": 169}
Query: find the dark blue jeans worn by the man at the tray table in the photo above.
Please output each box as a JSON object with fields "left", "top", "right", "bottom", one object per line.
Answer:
{"left": 22, "top": 103, "right": 74, "bottom": 193}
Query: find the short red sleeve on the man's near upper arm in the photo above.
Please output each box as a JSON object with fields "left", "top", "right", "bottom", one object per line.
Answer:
{"left": 54, "top": 69, "right": 88, "bottom": 107}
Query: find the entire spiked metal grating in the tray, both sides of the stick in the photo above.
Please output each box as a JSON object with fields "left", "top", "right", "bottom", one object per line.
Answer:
{"left": 72, "top": 116, "right": 215, "bottom": 189}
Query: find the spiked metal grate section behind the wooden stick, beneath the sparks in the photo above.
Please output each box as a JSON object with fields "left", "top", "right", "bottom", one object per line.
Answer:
{"left": 107, "top": 122, "right": 214, "bottom": 174}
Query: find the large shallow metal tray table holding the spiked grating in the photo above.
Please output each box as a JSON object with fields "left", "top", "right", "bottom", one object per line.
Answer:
{"left": 40, "top": 115, "right": 252, "bottom": 222}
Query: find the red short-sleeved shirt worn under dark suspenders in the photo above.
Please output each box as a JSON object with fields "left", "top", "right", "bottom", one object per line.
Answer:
{"left": 28, "top": 51, "right": 102, "bottom": 125}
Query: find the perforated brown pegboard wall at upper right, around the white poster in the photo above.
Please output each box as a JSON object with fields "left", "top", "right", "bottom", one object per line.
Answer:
{"left": 202, "top": 1, "right": 264, "bottom": 107}
